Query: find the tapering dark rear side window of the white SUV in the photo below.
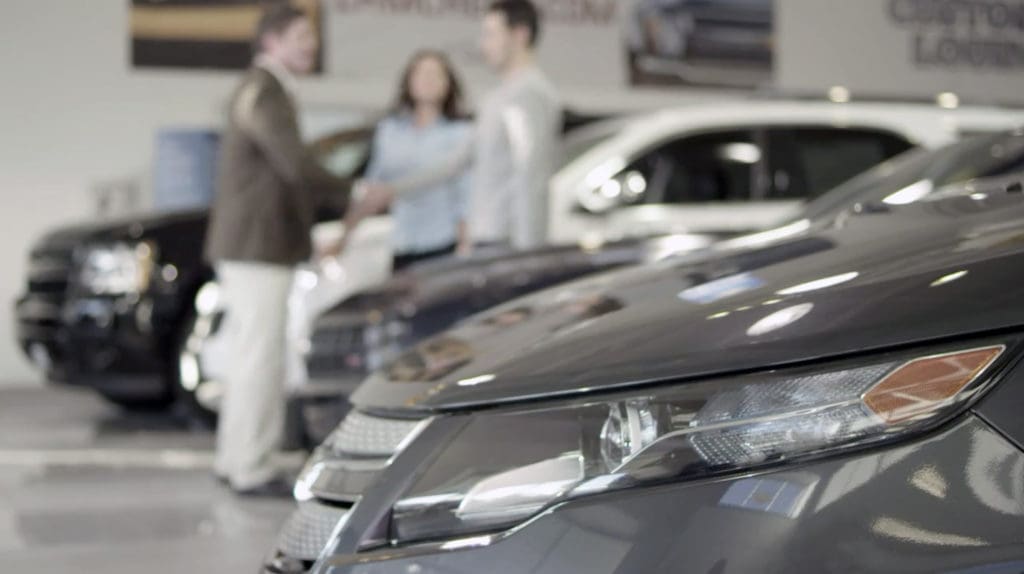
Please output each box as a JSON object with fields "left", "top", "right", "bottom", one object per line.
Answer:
{"left": 768, "top": 127, "right": 912, "bottom": 200}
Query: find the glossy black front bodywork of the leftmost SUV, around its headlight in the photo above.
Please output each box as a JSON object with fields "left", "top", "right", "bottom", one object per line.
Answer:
{"left": 16, "top": 211, "right": 211, "bottom": 400}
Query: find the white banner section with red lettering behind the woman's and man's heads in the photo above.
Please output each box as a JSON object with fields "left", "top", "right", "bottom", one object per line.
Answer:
{"left": 325, "top": 0, "right": 626, "bottom": 88}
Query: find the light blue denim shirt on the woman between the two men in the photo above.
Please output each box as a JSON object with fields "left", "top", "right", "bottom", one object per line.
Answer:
{"left": 366, "top": 114, "right": 473, "bottom": 255}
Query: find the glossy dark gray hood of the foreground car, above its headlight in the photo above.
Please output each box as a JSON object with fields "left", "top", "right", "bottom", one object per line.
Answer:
{"left": 352, "top": 177, "right": 1024, "bottom": 411}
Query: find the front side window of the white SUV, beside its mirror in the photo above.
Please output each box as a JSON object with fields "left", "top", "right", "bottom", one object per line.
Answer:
{"left": 621, "top": 131, "right": 764, "bottom": 205}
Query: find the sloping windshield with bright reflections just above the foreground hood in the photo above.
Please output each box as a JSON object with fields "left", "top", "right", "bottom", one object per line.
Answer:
{"left": 801, "top": 132, "right": 1024, "bottom": 220}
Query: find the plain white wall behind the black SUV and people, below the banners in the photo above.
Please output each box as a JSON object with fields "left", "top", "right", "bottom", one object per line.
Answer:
{"left": 0, "top": 0, "right": 729, "bottom": 386}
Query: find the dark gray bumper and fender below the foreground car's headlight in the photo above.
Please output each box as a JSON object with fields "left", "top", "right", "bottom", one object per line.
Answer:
{"left": 314, "top": 415, "right": 1024, "bottom": 574}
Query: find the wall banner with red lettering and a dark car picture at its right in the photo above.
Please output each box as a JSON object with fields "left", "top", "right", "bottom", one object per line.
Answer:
{"left": 326, "top": 0, "right": 774, "bottom": 89}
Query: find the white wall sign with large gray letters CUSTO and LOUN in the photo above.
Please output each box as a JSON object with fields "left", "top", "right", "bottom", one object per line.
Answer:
{"left": 776, "top": 0, "right": 1024, "bottom": 105}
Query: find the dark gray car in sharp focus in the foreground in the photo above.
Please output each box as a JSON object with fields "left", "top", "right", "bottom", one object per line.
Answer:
{"left": 270, "top": 133, "right": 1024, "bottom": 573}
